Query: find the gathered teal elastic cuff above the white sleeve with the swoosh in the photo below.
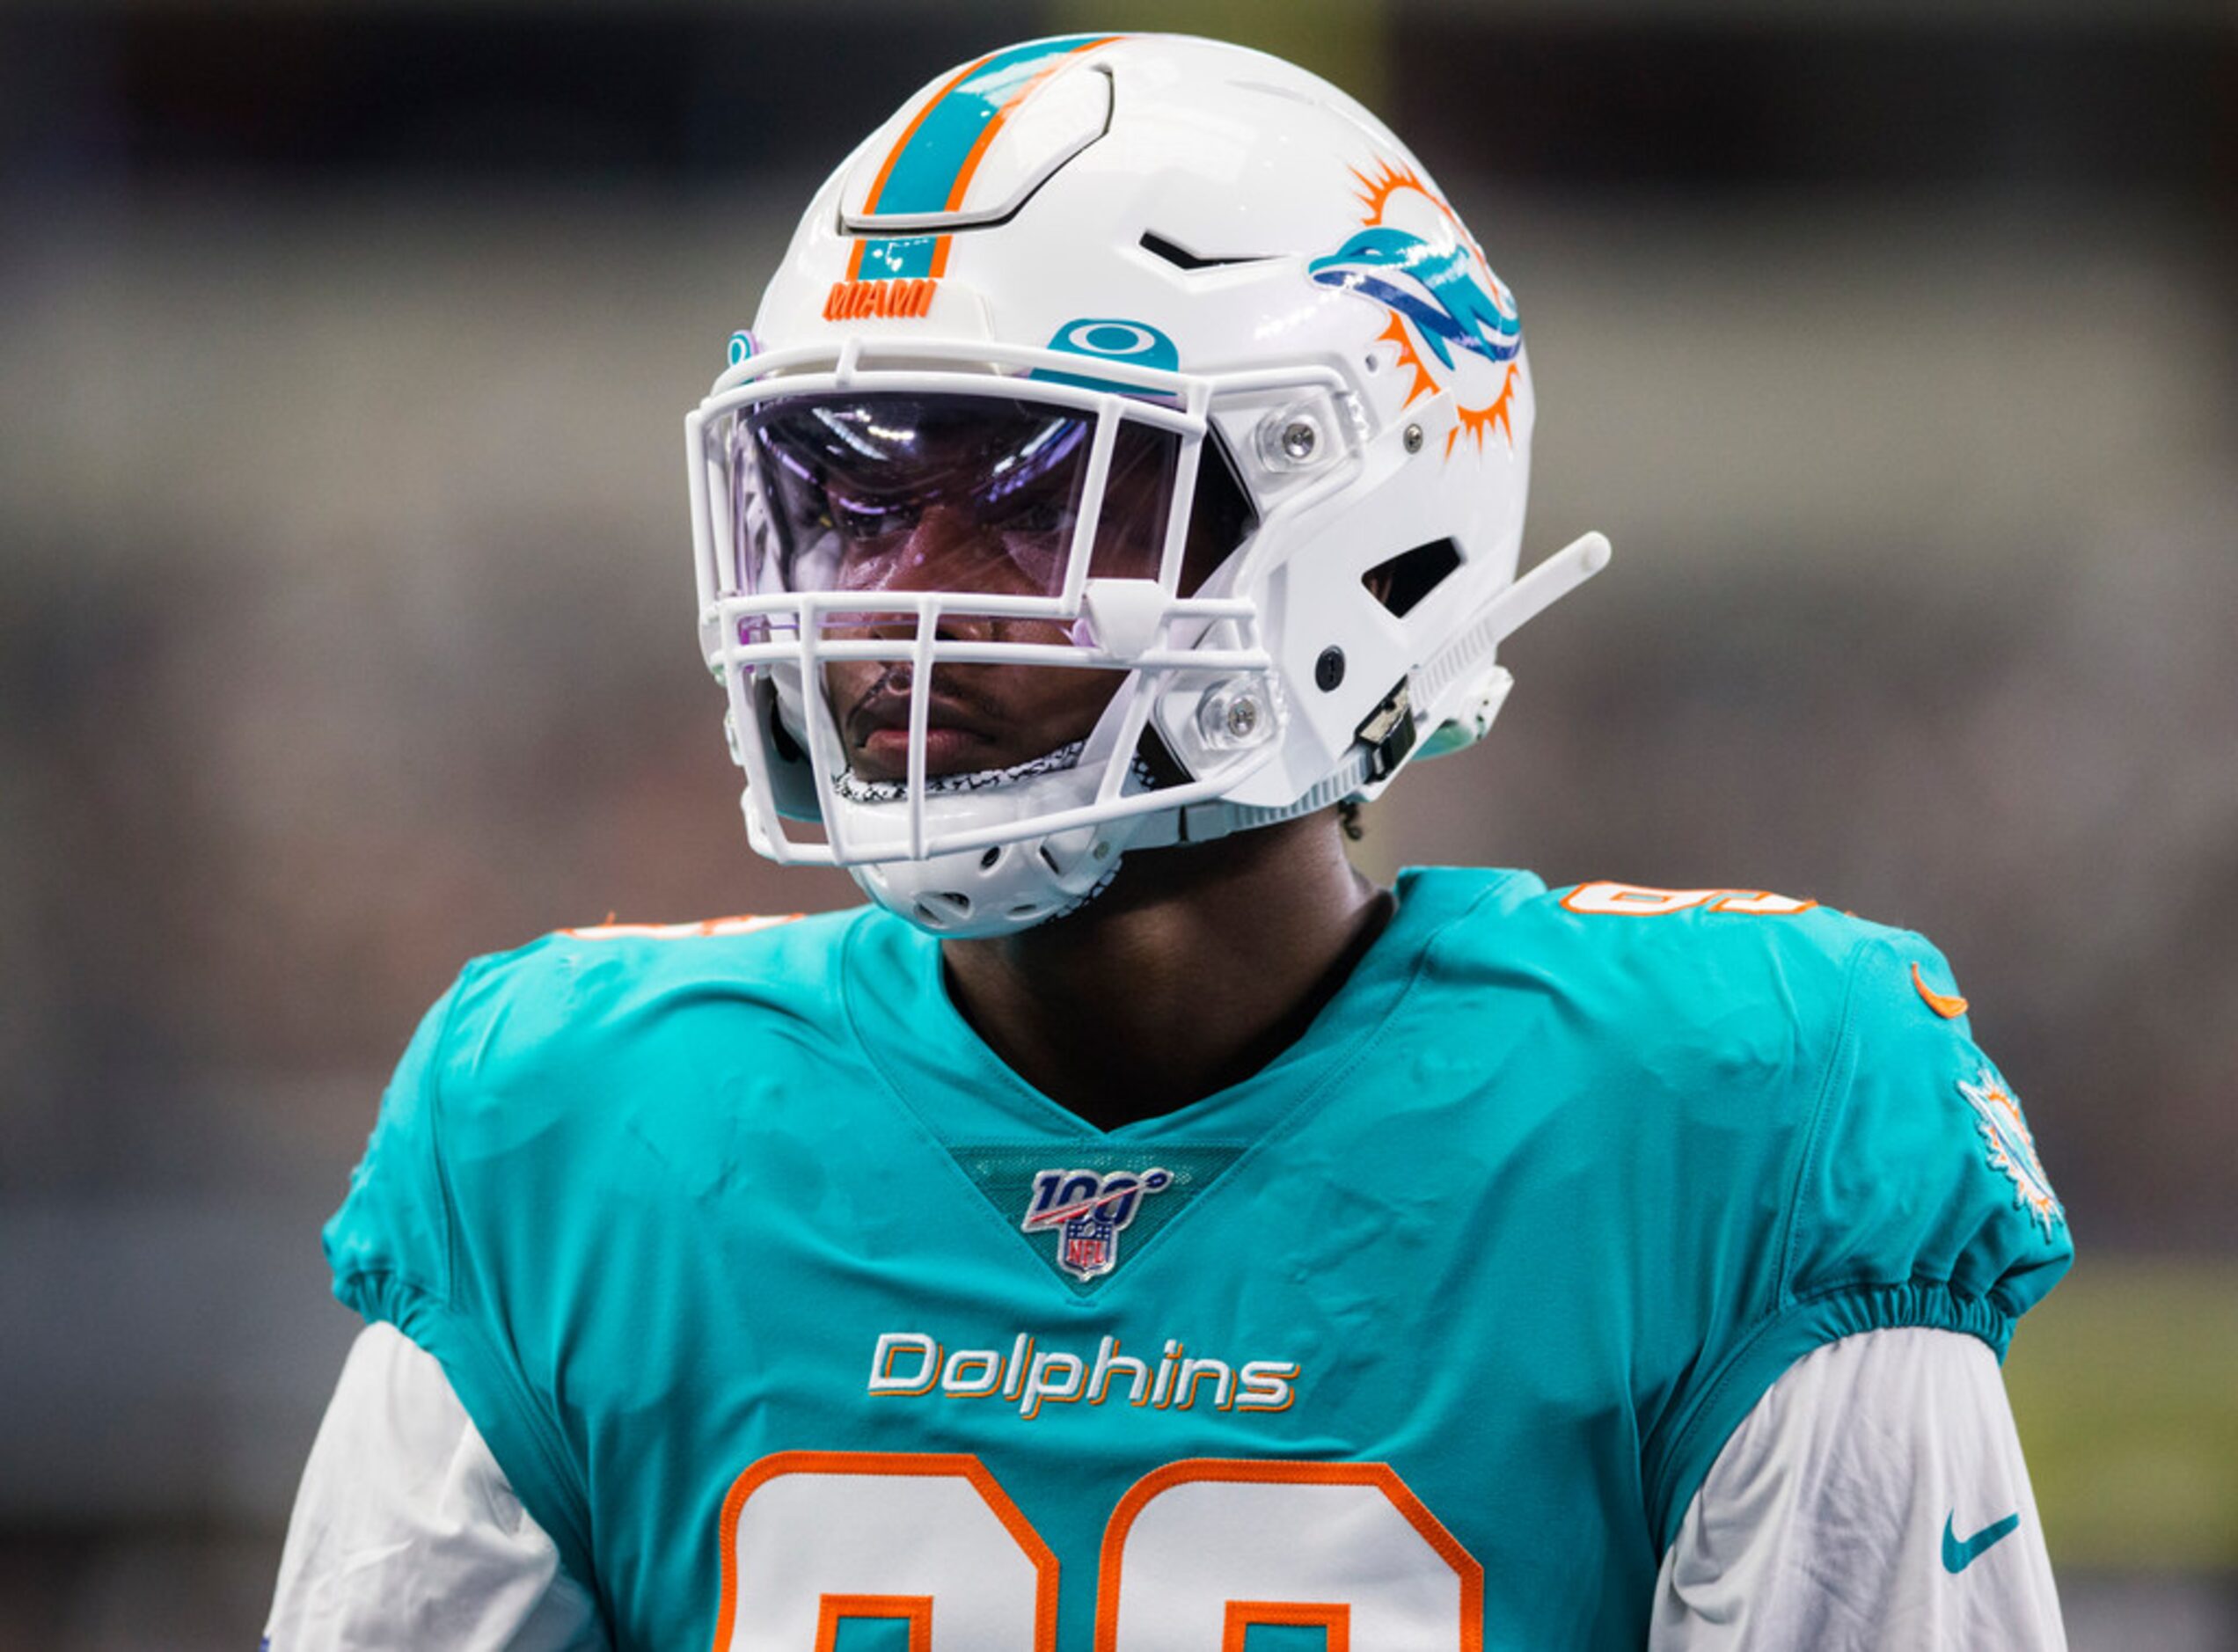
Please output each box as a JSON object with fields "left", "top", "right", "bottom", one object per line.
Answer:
{"left": 1642, "top": 1281, "right": 2012, "bottom": 1558}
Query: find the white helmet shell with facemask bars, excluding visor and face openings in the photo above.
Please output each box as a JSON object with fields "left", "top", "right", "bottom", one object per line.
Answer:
{"left": 687, "top": 36, "right": 1607, "bottom": 936}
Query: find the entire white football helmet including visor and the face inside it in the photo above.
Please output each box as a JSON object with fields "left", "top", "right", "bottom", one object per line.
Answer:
{"left": 684, "top": 36, "right": 1609, "bottom": 936}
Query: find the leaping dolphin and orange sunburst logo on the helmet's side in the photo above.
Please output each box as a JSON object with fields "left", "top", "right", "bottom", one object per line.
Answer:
{"left": 1305, "top": 164, "right": 1524, "bottom": 457}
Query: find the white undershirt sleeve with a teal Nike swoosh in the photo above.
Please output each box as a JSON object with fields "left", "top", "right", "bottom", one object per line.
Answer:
{"left": 1647, "top": 1327, "right": 2066, "bottom": 1652}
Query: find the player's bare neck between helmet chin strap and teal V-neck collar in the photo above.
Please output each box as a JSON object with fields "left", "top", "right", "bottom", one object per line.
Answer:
{"left": 942, "top": 813, "right": 1392, "bottom": 1129}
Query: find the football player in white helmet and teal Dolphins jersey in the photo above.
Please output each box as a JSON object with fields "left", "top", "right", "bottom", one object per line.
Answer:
{"left": 268, "top": 36, "right": 2070, "bottom": 1652}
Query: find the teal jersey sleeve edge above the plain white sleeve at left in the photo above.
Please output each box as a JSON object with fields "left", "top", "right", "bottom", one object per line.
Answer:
{"left": 333, "top": 1274, "right": 602, "bottom": 1598}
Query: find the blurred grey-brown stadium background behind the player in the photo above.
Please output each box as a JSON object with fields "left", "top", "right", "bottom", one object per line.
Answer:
{"left": 0, "top": 0, "right": 2238, "bottom": 1652}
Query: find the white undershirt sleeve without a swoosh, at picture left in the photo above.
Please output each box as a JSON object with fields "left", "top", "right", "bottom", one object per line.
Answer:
{"left": 264, "top": 1325, "right": 606, "bottom": 1652}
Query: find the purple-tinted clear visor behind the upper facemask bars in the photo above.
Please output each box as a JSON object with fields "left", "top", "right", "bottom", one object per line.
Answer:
{"left": 729, "top": 394, "right": 1181, "bottom": 596}
